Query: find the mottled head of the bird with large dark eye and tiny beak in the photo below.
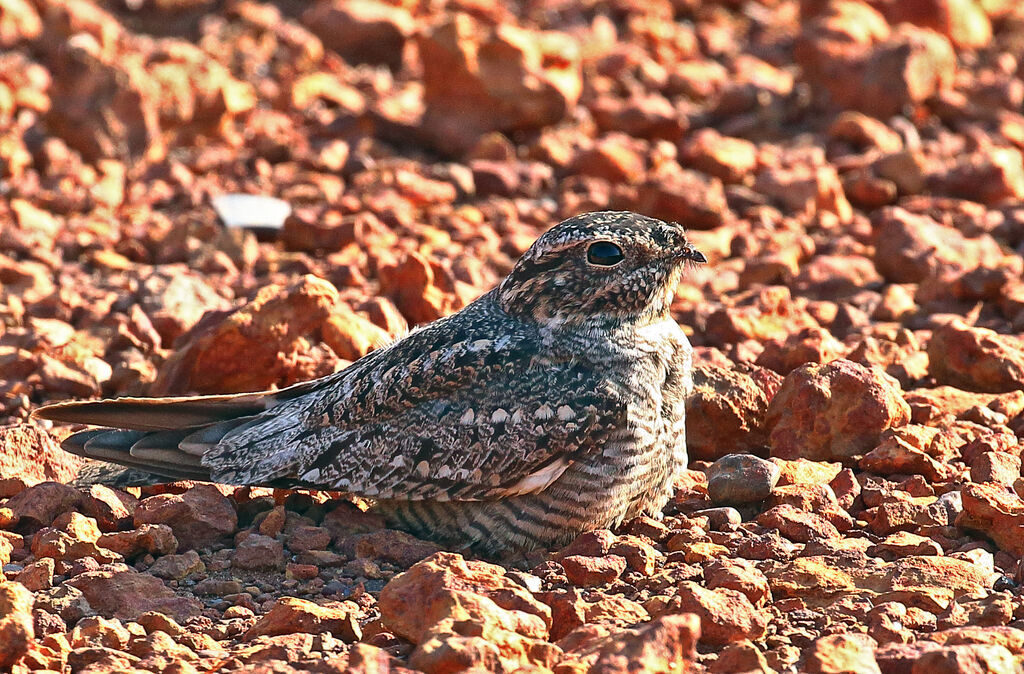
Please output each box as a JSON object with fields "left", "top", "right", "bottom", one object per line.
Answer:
{"left": 498, "top": 211, "right": 707, "bottom": 326}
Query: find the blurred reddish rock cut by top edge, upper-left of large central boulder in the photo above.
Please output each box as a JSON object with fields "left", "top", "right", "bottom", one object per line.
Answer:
{"left": 302, "top": 0, "right": 416, "bottom": 70}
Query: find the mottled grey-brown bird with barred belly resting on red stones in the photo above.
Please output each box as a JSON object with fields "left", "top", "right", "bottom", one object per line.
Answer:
{"left": 36, "top": 211, "right": 706, "bottom": 555}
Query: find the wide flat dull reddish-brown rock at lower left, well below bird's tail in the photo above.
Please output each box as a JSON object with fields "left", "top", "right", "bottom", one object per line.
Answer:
{"left": 67, "top": 564, "right": 202, "bottom": 621}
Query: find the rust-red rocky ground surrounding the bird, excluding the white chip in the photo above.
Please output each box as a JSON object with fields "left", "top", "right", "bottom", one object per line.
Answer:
{"left": 0, "top": 0, "right": 1024, "bottom": 674}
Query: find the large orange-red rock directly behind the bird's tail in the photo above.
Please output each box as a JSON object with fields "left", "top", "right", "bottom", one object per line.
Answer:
{"left": 151, "top": 276, "right": 338, "bottom": 395}
